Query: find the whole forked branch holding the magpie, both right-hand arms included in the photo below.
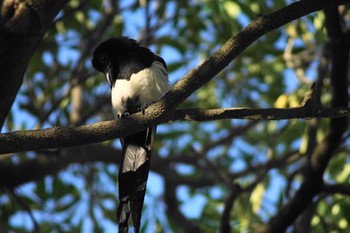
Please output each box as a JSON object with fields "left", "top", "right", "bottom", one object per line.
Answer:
{"left": 0, "top": 0, "right": 349, "bottom": 153}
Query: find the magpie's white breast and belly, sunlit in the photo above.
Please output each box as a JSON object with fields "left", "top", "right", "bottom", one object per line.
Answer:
{"left": 111, "top": 61, "right": 171, "bottom": 116}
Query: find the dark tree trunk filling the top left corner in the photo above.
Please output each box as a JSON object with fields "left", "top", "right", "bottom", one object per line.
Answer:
{"left": 0, "top": 0, "right": 68, "bottom": 129}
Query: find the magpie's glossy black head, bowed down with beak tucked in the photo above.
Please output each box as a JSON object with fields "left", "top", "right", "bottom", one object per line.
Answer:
{"left": 91, "top": 37, "right": 154, "bottom": 86}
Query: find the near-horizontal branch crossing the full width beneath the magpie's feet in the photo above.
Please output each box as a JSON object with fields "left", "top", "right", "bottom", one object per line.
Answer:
{"left": 0, "top": 89, "right": 350, "bottom": 154}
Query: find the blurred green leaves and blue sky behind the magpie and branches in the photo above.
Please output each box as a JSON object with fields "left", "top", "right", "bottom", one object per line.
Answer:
{"left": 0, "top": 0, "right": 350, "bottom": 232}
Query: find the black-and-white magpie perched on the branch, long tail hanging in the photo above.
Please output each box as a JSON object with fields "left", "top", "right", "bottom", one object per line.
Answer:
{"left": 92, "top": 37, "right": 171, "bottom": 233}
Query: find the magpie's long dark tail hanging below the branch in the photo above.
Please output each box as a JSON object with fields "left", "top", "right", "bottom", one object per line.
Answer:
{"left": 117, "top": 127, "right": 156, "bottom": 233}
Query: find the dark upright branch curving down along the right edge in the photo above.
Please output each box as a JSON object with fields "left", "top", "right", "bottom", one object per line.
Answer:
{"left": 263, "top": 5, "right": 350, "bottom": 233}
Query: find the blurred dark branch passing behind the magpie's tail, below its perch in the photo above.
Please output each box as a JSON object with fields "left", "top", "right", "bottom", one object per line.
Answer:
{"left": 0, "top": 145, "right": 217, "bottom": 190}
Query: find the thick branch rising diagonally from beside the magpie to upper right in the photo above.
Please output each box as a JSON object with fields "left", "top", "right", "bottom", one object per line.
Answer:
{"left": 161, "top": 0, "right": 349, "bottom": 110}
